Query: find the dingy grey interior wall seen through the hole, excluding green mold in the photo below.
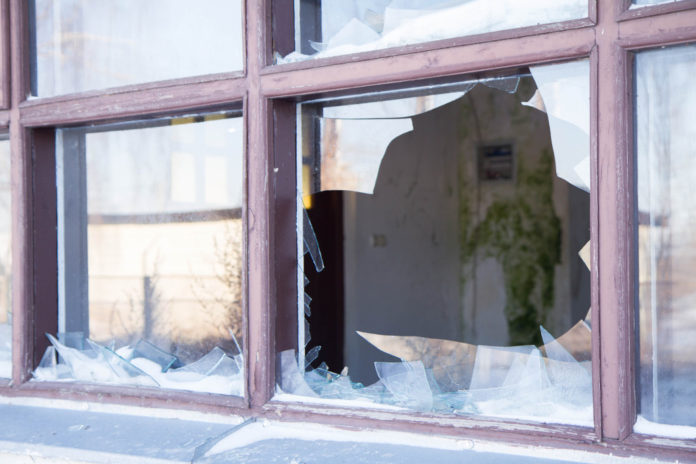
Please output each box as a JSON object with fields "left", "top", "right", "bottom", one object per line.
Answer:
{"left": 342, "top": 82, "right": 589, "bottom": 383}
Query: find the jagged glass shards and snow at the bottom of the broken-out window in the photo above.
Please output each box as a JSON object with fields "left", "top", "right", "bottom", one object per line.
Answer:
{"left": 277, "top": 321, "right": 592, "bottom": 425}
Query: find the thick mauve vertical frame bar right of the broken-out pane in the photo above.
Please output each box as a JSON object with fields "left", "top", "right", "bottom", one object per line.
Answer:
{"left": 593, "top": 1, "right": 635, "bottom": 440}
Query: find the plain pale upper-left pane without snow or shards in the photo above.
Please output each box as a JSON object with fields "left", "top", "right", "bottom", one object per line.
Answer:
{"left": 29, "top": 0, "right": 243, "bottom": 97}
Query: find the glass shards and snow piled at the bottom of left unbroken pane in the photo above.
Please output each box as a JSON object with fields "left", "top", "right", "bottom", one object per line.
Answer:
{"left": 33, "top": 333, "right": 244, "bottom": 396}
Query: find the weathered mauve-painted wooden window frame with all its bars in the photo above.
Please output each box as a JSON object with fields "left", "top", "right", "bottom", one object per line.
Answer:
{"left": 0, "top": 0, "right": 696, "bottom": 459}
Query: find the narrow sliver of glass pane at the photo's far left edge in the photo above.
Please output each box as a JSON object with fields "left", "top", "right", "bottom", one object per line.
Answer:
{"left": 0, "top": 140, "right": 12, "bottom": 378}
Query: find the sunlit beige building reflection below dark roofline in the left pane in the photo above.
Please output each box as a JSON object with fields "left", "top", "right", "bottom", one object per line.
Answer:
{"left": 88, "top": 218, "right": 242, "bottom": 361}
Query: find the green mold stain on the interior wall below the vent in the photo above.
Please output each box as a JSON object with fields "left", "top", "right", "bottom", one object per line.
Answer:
{"left": 459, "top": 150, "right": 561, "bottom": 345}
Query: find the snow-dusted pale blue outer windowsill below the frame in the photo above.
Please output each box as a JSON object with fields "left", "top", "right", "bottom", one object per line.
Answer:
{"left": 0, "top": 398, "right": 676, "bottom": 464}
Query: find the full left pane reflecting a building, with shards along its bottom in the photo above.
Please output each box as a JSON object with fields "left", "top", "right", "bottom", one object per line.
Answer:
{"left": 34, "top": 112, "right": 244, "bottom": 395}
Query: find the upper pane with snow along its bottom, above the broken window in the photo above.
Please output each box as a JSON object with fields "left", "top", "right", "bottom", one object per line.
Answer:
{"left": 274, "top": 0, "right": 588, "bottom": 63}
